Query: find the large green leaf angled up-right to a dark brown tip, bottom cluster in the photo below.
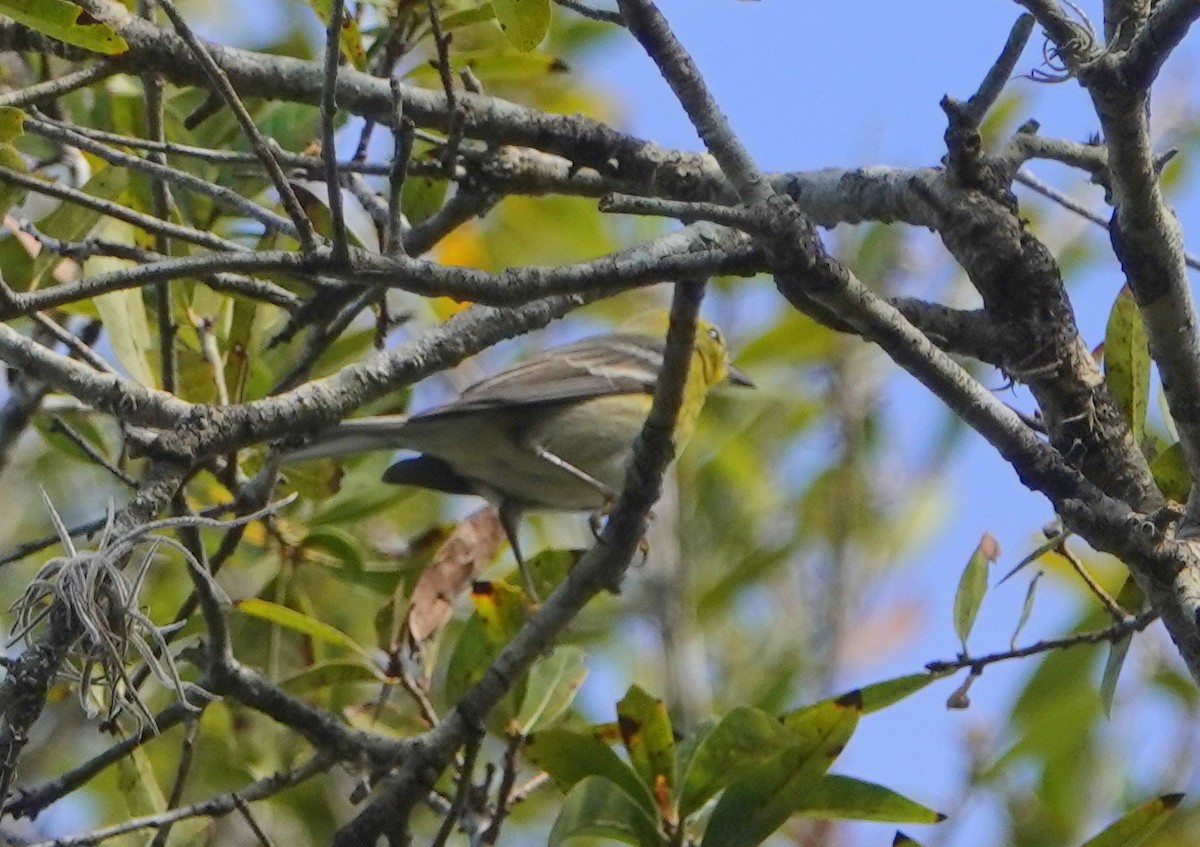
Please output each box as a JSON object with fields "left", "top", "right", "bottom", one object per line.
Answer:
{"left": 703, "top": 697, "right": 863, "bottom": 847}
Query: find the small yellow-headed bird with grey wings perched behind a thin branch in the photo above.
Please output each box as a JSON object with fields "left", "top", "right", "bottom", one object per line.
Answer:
{"left": 284, "top": 320, "right": 754, "bottom": 596}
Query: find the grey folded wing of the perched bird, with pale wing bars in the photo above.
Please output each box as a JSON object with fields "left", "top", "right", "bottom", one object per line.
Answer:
{"left": 410, "top": 332, "right": 664, "bottom": 420}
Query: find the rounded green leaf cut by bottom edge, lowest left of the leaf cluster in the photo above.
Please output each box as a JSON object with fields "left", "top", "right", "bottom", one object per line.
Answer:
{"left": 547, "top": 776, "right": 666, "bottom": 847}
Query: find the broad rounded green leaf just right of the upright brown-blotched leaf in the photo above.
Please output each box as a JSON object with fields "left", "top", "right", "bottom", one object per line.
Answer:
{"left": 679, "top": 705, "right": 791, "bottom": 818}
